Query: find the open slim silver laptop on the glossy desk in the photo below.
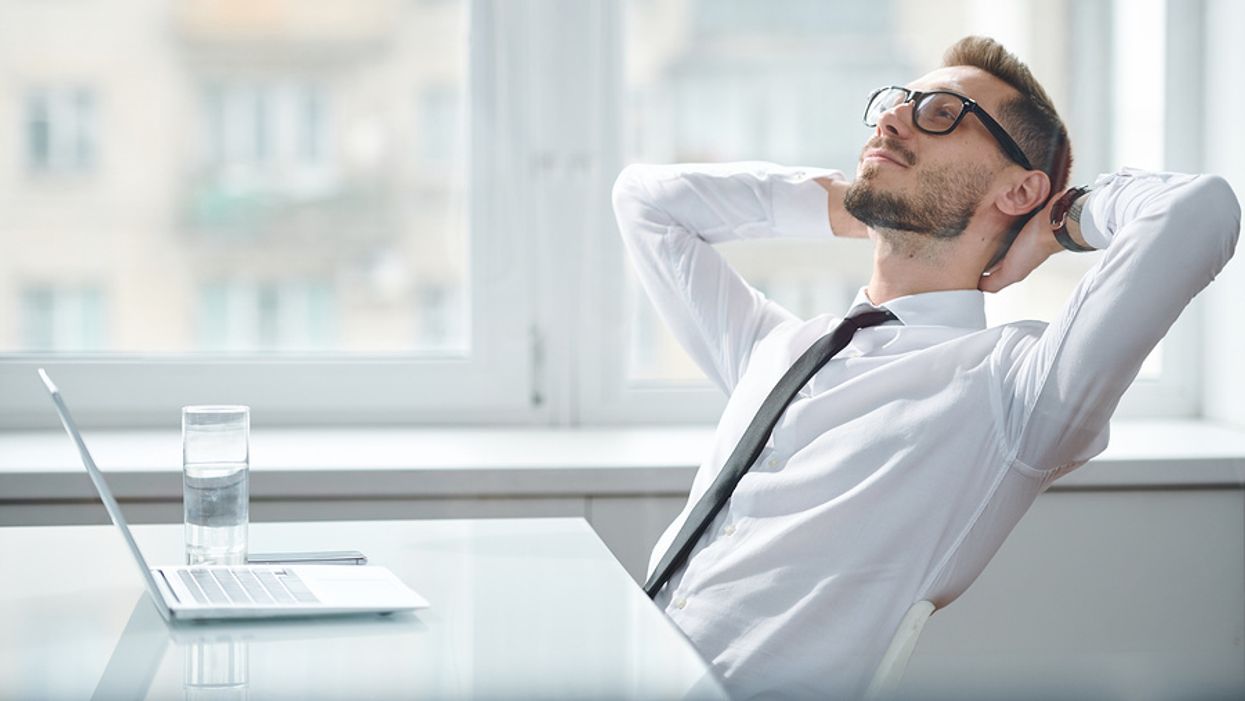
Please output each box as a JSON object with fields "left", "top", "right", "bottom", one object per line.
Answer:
{"left": 39, "top": 369, "right": 428, "bottom": 620}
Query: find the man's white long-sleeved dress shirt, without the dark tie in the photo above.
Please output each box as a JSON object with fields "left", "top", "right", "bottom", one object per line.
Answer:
{"left": 614, "top": 162, "right": 1240, "bottom": 699}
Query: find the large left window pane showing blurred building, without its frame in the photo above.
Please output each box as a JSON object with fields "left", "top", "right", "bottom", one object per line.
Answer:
{"left": 0, "top": 0, "right": 471, "bottom": 357}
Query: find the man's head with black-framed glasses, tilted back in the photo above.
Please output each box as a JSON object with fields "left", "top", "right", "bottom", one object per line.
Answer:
{"left": 844, "top": 36, "right": 1072, "bottom": 268}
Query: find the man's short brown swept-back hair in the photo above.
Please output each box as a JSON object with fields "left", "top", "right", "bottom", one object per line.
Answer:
{"left": 942, "top": 36, "right": 1072, "bottom": 265}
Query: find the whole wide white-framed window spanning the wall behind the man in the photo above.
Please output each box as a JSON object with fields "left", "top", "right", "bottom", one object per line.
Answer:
{"left": 0, "top": 0, "right": 1204, "bottom": 427}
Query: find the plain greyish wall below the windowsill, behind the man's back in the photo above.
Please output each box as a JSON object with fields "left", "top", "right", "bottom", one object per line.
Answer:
{"left": 903, "top": 489, "right": 1245, "bottom": 701}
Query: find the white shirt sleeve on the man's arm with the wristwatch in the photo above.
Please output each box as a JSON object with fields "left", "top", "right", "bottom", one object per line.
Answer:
{"left": 1003, "top": 168, "right": 1241, "bottom": 471}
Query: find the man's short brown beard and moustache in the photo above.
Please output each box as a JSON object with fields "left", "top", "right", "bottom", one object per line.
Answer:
{"left": 843, "top": 143, "right": 992, "bottom": 239}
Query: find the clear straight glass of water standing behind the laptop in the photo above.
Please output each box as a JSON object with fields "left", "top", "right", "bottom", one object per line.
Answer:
{"left": 182, "top": 406, "right": 250, "bottom": 565}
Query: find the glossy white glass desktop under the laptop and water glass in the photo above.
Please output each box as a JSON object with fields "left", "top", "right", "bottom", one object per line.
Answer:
{"left": 0, "top": 519, "right": 726, "bottom": 700}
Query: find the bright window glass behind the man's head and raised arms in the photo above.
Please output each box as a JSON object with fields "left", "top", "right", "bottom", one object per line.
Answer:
{"left": 587, "top": 0, "right": 1195, "bottom": 420}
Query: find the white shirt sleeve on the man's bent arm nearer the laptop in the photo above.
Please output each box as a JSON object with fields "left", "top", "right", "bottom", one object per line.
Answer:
{"left": 614, "top": 162, "right": 843, "bottom": 393}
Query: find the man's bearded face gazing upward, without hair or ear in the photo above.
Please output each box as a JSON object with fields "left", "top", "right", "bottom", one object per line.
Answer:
{"left": 844, "top": 66, "right": 1015, "bottom": 239}
